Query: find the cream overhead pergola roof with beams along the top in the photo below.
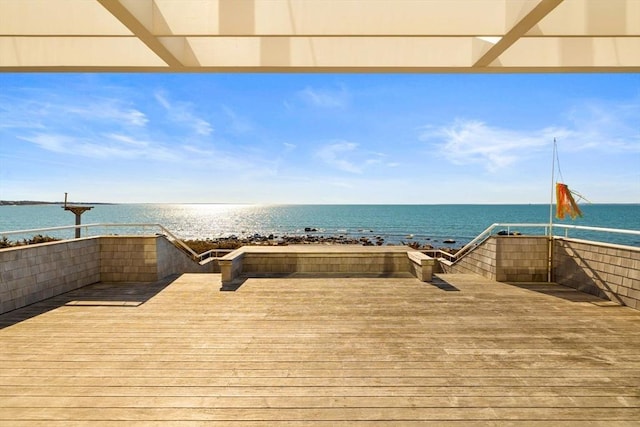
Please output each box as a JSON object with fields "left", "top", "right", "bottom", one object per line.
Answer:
{"left": 0, "top": 0, "right": 640, "bottom": 73}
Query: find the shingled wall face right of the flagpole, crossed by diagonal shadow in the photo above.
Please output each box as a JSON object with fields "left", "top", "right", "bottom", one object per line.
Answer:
{"left": 553, "top": 238, "right": 640, "bottom": 309}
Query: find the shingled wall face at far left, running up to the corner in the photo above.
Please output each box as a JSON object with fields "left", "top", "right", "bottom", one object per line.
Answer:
{"left": 0, "top": 238, "right": 101, "bottom": 313}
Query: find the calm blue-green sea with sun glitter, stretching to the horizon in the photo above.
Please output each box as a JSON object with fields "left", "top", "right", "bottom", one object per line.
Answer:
{"left": 0, "top": 204, "right": 640, "bottom": 246}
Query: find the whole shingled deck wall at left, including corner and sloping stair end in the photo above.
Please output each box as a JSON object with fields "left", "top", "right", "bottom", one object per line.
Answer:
{"left": 0, "top": 236, "right": 220, "bottom": 314}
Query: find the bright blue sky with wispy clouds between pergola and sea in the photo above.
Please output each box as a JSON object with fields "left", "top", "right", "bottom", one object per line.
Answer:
{"left": 0, "top": 73, "right": 640, "bottom": 204}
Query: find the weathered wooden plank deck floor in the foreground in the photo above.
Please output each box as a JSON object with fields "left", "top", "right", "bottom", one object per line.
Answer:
{"left": 0, "top": 274, "right": 640, "bottom": 427}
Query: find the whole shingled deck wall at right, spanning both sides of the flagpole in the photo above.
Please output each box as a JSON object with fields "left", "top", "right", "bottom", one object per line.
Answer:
{"left": 440, "top": 236, "right": 640, "bottom": 309}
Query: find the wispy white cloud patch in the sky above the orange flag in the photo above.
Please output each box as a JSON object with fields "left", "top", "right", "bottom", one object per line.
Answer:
{"left": 419, "top": 102, "right": 640, "bottom": 172}
